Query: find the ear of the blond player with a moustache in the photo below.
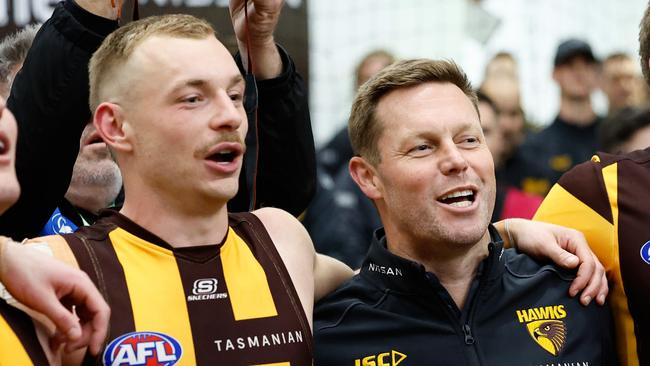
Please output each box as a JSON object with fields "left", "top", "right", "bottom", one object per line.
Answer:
{"left": 93, "top": 102, "right": 133, "bottom": 152}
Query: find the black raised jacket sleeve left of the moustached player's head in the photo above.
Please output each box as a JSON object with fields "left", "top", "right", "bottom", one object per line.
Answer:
{"left": 0, "top": 0, "right": 117, "bottom": 240}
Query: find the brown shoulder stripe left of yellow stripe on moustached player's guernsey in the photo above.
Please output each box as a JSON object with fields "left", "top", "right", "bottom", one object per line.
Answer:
{"left": 65, "top": 221, "right": 135, "bottom": 365}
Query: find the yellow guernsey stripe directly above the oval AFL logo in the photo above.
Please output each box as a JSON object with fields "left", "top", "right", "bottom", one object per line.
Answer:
{"left": 109, "top": 228, "right": 196, "bottom": 366}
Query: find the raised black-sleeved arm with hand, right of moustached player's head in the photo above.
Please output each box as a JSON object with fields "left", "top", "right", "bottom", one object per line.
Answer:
{"left": 228, "top": 0, "right": 316, "bottom": 216}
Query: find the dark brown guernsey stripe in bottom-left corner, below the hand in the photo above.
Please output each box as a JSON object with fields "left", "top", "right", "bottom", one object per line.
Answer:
{"left": 0, "top": 300, "right": 48, "bottom": 365}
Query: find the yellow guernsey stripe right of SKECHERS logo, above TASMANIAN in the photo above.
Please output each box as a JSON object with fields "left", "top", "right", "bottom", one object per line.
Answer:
{"left": 221, "top": 228, "right": 278, "bottom": 320}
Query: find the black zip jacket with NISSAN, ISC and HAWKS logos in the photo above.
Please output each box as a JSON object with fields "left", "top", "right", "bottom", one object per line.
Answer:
{"left": 314, "top": 228, "right": 616, "bottom": 366}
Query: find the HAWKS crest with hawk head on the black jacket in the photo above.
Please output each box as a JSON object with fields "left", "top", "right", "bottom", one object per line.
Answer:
{"left": 517, "top": 305, "right": 567, "bottom": 356}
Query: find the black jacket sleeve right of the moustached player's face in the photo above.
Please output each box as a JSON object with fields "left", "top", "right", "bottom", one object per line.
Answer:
{"left": 229, "top": 47, "right": 316, "bottom": 216}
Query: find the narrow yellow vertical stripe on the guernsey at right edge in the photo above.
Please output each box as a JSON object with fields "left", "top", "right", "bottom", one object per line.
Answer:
{"left": 603, "top": 164, "right": 639, "bottom": 366}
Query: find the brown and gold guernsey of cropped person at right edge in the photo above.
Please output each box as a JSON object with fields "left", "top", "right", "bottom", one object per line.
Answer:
{"left": 535, "top": 148, "right": 650, "bottom": 366}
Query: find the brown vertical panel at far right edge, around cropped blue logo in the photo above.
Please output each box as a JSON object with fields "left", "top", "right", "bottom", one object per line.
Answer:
{"left": 618, "top": 156, "right": 650, "bottom": 365}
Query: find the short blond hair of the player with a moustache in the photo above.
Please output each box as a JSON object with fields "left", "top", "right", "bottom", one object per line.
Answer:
{"left": 88, "top": 14, "right": 215, "bottom": 111}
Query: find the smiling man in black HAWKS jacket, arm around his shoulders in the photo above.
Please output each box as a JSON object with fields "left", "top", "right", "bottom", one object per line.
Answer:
{"left": 314, "top": 60, "right": 616, "bottom": 366}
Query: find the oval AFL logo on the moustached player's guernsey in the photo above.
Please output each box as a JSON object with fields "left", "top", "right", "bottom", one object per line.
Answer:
{"left": 103, "top": 332, "right": 183, "bottom": 366}
